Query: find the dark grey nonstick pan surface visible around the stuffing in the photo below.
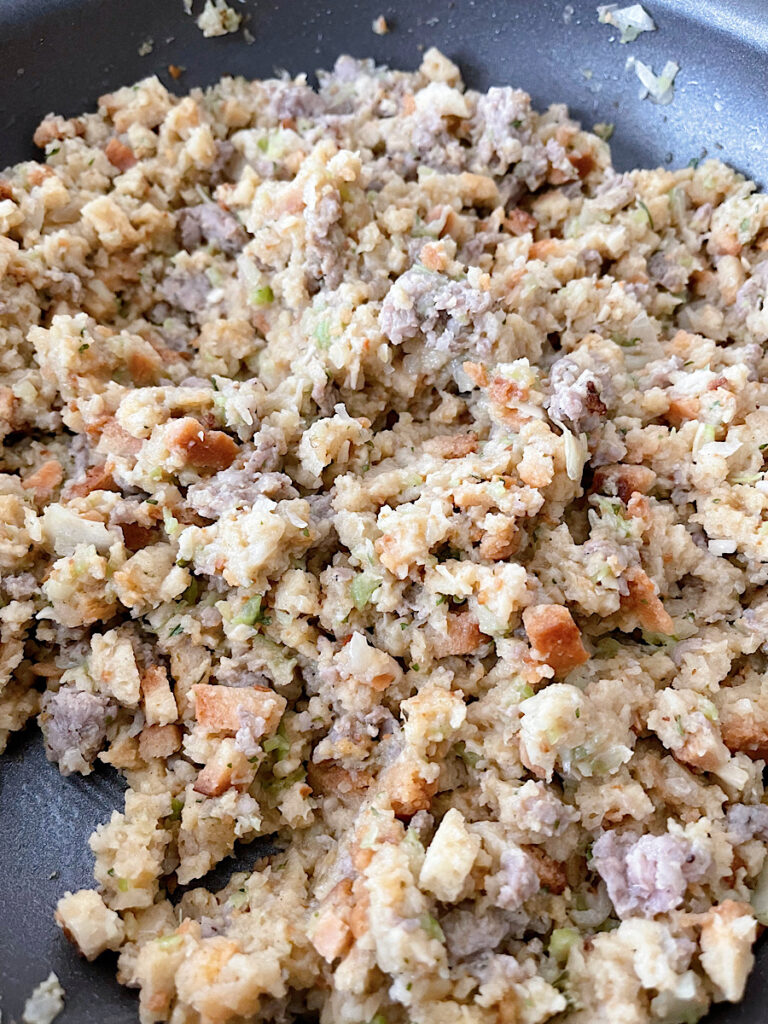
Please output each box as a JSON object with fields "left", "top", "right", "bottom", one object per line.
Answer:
{"left": 0, "top": 0, "right": 768, "bottom": 1024}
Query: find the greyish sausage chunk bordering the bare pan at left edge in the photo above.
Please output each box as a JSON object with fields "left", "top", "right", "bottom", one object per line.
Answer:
{"left": 40, "top": 686, "right": 110, "bottom": 775}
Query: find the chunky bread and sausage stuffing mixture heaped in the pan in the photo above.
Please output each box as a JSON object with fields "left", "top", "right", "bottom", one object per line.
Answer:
{"left": 0, "top": 50, "right": 768, "bottom": 1024}
